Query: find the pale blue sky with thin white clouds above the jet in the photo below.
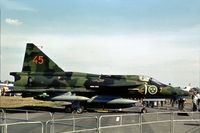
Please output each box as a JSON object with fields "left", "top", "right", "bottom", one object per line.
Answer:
{"left": 1, "top": 0, "right": 200, "bottom": 87}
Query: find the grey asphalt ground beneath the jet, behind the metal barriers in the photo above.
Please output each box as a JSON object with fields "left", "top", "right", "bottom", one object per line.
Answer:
{"left": 0, "top": 106, "right": 200, "bottom": 133}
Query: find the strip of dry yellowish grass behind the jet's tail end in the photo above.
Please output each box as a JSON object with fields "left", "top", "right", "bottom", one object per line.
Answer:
{"left": 0, "top": 96, "right": 58, "bottom": 108}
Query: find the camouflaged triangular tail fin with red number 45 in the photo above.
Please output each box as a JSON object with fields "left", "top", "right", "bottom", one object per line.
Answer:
{"left": 22, "top": 43, "right": 63, "bottom": 72}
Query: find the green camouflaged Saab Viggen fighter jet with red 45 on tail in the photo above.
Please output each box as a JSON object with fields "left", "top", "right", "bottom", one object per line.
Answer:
{"left": 10, "top": 43, "right": 188, "bottom": 112}
